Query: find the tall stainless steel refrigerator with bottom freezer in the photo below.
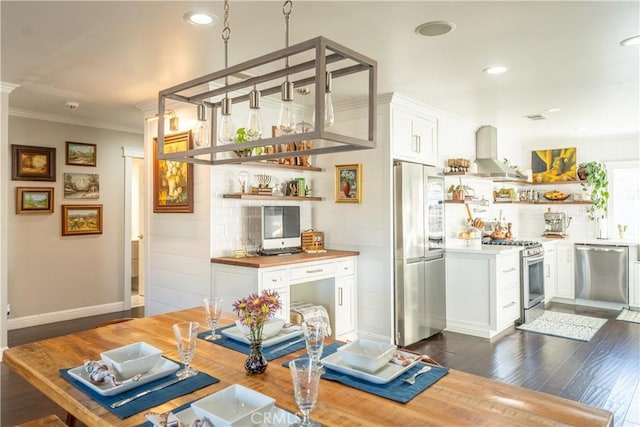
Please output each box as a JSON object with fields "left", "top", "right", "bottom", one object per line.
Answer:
{"left": 393, "top": 161, "right": 446, "bottom": 347}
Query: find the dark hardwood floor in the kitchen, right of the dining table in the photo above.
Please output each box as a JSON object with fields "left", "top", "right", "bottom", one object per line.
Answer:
{"left": 409, "top": 303, "right": 640, "bottom": 427}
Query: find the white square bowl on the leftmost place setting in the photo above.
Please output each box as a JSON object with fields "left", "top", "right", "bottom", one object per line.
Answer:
{"left": 100, "top": 342, "right": 162, "bottom": 378}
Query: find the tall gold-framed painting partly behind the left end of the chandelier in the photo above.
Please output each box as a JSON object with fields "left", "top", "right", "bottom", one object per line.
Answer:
{"left": 153, "top": 131, "right": 193, "bottom": 213}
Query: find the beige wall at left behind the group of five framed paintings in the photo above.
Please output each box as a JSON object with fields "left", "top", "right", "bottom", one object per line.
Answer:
{"left": 5, "top": 116, "right": 142, "bottom": 328}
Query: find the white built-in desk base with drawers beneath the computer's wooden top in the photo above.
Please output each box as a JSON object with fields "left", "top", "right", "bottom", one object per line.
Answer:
{"left": 212, "top": 256, "right": 357, "bottom": 340}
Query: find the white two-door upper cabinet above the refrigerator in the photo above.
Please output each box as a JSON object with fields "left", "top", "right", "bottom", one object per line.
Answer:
{"left": 391, "top": 107, "right": 438, "bottom": 166}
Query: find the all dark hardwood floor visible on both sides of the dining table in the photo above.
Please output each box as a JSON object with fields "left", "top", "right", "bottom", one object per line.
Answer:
{"left": 0, "top": 304, "right": 640, "bottom": 427}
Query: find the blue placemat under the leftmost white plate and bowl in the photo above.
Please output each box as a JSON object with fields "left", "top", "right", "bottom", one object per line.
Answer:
{"left": 59, "top": 362, "right": 220, "bottom": 419}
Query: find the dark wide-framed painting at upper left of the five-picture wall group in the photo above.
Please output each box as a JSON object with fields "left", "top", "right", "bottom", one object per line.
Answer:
{"left": 11, "top": 144, "right": 56, "bottom": 181}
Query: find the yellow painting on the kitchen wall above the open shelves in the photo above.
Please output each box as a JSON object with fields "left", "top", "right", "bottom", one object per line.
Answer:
{"left": 531, "top": 147, "right": 577, "bottom": 183}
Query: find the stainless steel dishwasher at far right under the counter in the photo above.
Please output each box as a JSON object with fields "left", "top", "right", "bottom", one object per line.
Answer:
{"left": 575, "top": 244, "right": 629, "bottom": 304}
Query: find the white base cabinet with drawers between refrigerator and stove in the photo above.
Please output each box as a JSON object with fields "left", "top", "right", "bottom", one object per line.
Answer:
{"left": 447, "top": 250, "right": 520, "bottom": 338}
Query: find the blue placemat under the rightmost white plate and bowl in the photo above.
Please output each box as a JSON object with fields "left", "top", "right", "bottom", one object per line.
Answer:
{"left": 283, "top": 343, "right": 449, "bottom": 403}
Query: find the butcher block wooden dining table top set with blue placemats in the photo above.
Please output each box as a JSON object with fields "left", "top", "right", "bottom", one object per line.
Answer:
{"left": 3, "top": 307, "right": 613, "bottom": 427}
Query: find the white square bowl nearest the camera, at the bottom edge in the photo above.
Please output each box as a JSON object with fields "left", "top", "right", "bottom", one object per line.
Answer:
{"left": 191, "top": 384, "right": 276, "bottom": 427}
